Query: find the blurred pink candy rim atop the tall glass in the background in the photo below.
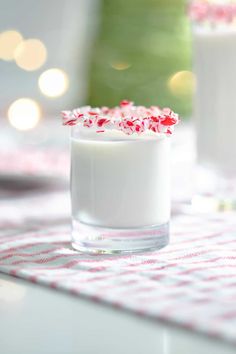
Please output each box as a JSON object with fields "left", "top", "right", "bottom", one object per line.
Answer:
{"left": 188, "top": 0, "right": 236, "bottom": 25}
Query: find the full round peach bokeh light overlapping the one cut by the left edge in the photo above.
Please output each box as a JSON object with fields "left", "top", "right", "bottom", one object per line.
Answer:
{"left": 14, "top": 39, "right": 47, "bottom": 71}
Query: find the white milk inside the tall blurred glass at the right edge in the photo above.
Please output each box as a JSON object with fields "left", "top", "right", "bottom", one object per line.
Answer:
{"left": 193, "top": 26, "right": 236, "bottom": 174}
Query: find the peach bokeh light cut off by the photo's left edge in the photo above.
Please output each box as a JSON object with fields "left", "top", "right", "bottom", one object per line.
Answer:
{"left": 0, "top": 30, "right": 23, "bottom": 60}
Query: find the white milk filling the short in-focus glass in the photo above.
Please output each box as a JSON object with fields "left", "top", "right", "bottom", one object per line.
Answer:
{"left": 71, "top": 129, "right": 170, "bottom": 228}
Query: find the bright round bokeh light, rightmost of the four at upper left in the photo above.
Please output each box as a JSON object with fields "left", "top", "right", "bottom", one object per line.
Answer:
{"left": 38, "top": 68, "right": 69, "bottom": 97}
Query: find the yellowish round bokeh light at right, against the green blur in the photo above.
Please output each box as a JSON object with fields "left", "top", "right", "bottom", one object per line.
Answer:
{"left": 168, "top": 71, "right": 196, "bottom": 97}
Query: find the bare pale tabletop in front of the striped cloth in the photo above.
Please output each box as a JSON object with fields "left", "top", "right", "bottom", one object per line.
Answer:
{"left": 0, "top": 122, "right": 235, "bottom": 354}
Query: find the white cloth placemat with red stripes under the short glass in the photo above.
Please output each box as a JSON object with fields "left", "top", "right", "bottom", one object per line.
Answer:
{"left": 0, "top": 192, "right": 236, "bottom": 344}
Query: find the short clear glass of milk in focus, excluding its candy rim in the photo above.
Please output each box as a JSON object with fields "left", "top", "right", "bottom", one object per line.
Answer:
{"left": 71, "top": 125, "right": 170, "bottom": 254}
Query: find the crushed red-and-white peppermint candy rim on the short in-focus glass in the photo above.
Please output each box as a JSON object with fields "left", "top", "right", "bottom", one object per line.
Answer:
{"left": 61, "top": 100, "right": 179, "bottom": 135}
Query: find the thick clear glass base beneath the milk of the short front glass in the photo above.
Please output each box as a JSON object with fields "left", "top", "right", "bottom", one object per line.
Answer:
{"left": 72, "top": 219, "right": 169, "bottom": 254}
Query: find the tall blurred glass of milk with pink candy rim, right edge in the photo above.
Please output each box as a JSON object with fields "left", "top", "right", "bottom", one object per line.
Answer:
{"left": 190, "top": 0, "right": 236, "bottom": 209}
